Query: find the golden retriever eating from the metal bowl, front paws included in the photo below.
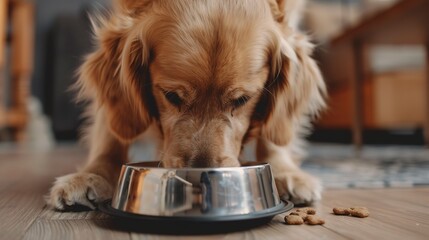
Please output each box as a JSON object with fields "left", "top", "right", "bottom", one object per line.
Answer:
{"left": 47, "top": 0, "right": 325, "bottom": 210}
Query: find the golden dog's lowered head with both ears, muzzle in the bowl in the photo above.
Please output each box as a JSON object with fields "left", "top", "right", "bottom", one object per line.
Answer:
{"left": 81, "top": 0, "right": 324, "bottom": 167}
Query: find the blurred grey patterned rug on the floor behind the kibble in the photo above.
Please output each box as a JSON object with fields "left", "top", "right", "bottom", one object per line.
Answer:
{"left": 303, "top": 145, "right": 429, "bottom": 188}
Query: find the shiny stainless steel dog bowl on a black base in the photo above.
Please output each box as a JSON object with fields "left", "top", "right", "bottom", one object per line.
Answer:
{"left": 109, "top": 162, "right": 292, "bottom": 220}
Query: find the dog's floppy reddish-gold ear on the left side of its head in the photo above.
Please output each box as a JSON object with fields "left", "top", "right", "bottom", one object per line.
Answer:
{"left": 78, "top": 19, "right": 156, "bottom": 142}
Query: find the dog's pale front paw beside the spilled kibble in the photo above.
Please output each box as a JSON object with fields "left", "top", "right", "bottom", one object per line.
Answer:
{"left": 275, "top": 171, "right": 322, "bottom": 205}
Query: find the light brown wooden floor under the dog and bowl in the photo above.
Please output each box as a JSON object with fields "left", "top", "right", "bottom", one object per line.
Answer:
{"left": 0, "top": 144, "right": 429, "bottom": 240}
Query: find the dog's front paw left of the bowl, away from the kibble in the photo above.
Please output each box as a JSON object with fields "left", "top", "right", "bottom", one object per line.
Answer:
{"left": 46, "top": 173, "right": 113, "bottom": 210}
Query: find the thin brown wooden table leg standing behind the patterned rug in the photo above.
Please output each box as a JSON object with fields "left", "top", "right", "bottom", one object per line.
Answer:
{"left": 351, "top": 41, "right": 364, "bottom": 152}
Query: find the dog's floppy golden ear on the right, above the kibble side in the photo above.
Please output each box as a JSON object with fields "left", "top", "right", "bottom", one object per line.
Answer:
{"left": 256, "top": 36, "right": 326, "bottom": 145}
